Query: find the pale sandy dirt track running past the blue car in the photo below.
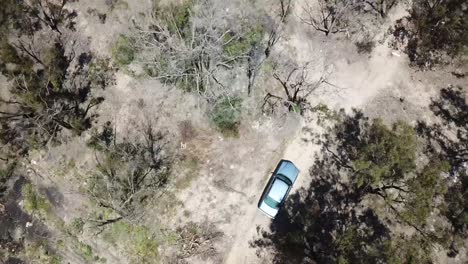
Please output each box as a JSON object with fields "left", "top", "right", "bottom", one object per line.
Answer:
{"left": 224, "top": 19, "right": 409, "bottom": 264}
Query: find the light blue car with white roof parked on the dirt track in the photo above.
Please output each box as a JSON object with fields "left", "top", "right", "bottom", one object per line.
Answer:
{"left": 258, "top": 160, "right": 299, "bottom": 218}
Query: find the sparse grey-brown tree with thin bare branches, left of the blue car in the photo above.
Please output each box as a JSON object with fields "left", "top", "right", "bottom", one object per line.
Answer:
{"left": 88, "top": 123, "right": 169, "bottom": 226}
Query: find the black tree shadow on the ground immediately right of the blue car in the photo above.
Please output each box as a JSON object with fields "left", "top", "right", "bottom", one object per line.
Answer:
{"left": 250, "top": 151, "right": 390, "bottom": 263}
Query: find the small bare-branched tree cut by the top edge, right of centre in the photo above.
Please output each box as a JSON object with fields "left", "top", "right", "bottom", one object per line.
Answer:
{"left": 299, "top": 0, "right": 351, "bottom": 36}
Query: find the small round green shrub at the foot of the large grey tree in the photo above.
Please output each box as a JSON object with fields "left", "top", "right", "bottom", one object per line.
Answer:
{"left": 211, "top": 97, "right": 242, "bottom": 135}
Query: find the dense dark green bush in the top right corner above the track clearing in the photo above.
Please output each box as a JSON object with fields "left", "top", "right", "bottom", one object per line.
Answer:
{"left": 394, "top": 0, "right": 468, "bottom": 67}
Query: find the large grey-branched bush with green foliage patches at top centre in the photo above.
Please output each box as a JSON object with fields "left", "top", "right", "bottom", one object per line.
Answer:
{"left": 135, "top": 0, "right": 265, "bottom": 99}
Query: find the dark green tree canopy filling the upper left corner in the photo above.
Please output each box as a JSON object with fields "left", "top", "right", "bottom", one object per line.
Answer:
{"left": 0, "top": 0, "right": 107, "bottom": 159}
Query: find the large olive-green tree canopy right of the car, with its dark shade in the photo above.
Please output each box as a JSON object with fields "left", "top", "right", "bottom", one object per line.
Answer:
{"left": 251, "top": 104, "right": 466, "bottom": 263}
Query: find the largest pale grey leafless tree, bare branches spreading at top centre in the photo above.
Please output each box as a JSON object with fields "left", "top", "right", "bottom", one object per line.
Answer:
{"left": 135, "top": 0, "right": 249, "bottom": 101}
